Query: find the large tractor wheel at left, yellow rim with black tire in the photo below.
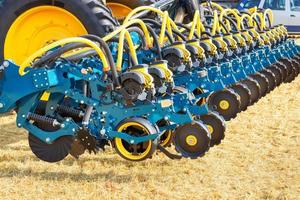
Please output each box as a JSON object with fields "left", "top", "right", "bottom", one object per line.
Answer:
{"left": 0, "top": 0, "right": 118, "bottom": 64}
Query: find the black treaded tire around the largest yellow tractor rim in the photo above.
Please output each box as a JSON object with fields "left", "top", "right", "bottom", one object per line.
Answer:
{"left": 0, "top": 0, "right": 118, "bottom": 62}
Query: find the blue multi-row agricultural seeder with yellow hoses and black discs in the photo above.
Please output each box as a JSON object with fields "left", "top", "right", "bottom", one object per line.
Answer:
{"left": 0, "top": 1, "right": 300, "bottom": 162}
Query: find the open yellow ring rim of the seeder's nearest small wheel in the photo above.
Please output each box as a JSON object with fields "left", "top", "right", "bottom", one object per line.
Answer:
{"left": 115, "top": 122, "right": 152, "bottom": 160}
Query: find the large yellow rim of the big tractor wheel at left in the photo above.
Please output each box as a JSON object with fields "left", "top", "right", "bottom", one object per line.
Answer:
{"left": 4, "top": 6, "right": 87, "bottom": 64}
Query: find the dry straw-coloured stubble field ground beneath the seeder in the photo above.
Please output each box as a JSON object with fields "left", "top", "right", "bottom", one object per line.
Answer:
{"left": 0, "top": 78, "right": 300, "bottom": 200}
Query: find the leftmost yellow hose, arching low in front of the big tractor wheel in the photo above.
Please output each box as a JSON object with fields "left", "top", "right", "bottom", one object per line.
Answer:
{"left": 19, "top": 37, "right": 110, "bottom": 76}
